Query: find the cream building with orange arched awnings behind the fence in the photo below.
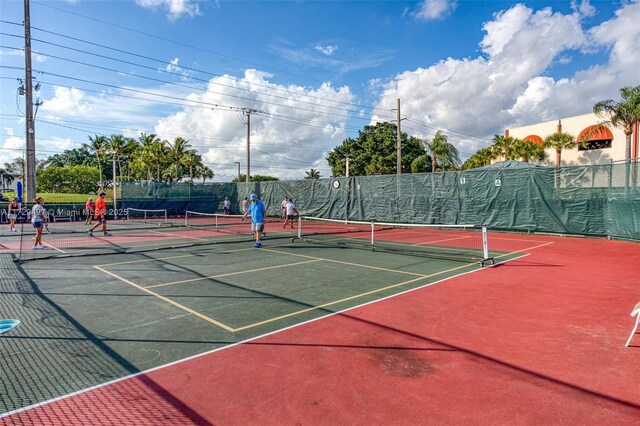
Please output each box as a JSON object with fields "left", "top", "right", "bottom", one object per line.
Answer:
{"left": 505, "top": 113, "right": 639, "bottom": 165}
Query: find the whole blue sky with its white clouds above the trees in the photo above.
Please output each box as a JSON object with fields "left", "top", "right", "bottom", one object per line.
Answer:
{"left": 0, "top": 0, "right": 640, "bottom": 181}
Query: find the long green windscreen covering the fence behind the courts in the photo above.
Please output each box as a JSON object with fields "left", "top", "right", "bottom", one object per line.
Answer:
{"left": 121, "top": 161, "right": 640, "bottom": 240}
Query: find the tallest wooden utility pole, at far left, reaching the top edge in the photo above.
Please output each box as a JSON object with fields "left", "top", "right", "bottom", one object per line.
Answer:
{"left": 24, "top": 0, "right": 36, "bottom": 200}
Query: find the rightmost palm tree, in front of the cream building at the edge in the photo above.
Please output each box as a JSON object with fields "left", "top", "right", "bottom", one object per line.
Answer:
{"left": 592, "top": 86, "right": 640, "bottom": 160}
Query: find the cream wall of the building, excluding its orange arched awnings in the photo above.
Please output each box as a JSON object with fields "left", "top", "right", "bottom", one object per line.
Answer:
{"left": 509, "top": 113, "right": 626, "bottom": 165}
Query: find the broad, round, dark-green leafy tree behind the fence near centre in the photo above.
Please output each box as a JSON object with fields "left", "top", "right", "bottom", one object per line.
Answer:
{"left": 327, "top": 122, "right": 425, "bottom": 176}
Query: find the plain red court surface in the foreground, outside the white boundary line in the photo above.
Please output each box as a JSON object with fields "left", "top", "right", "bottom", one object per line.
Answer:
{"left": 0, "top": 234, "right": 640, "bottom": 425}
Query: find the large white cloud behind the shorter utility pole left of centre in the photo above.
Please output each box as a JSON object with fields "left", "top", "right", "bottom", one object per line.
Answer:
{"left": 154, "top": 70, "right": 354, "bottom": 181}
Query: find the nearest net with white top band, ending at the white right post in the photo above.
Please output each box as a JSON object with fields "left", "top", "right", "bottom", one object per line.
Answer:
{"left": 298, "top": 217, "right": 494, "bottom": 266}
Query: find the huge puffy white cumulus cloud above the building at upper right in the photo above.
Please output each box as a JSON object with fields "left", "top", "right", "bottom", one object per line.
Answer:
{"left": 372, "top": 2, "right": 640, "bottom": 154}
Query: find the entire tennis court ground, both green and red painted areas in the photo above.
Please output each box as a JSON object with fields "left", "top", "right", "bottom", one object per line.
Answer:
{"left": 0, "top": 221, "right": 640, "bottom": 424}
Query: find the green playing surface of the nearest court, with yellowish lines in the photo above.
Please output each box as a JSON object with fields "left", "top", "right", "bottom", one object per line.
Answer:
{"left": 0, "top": 241, "right": 515, "bottom": 413}
